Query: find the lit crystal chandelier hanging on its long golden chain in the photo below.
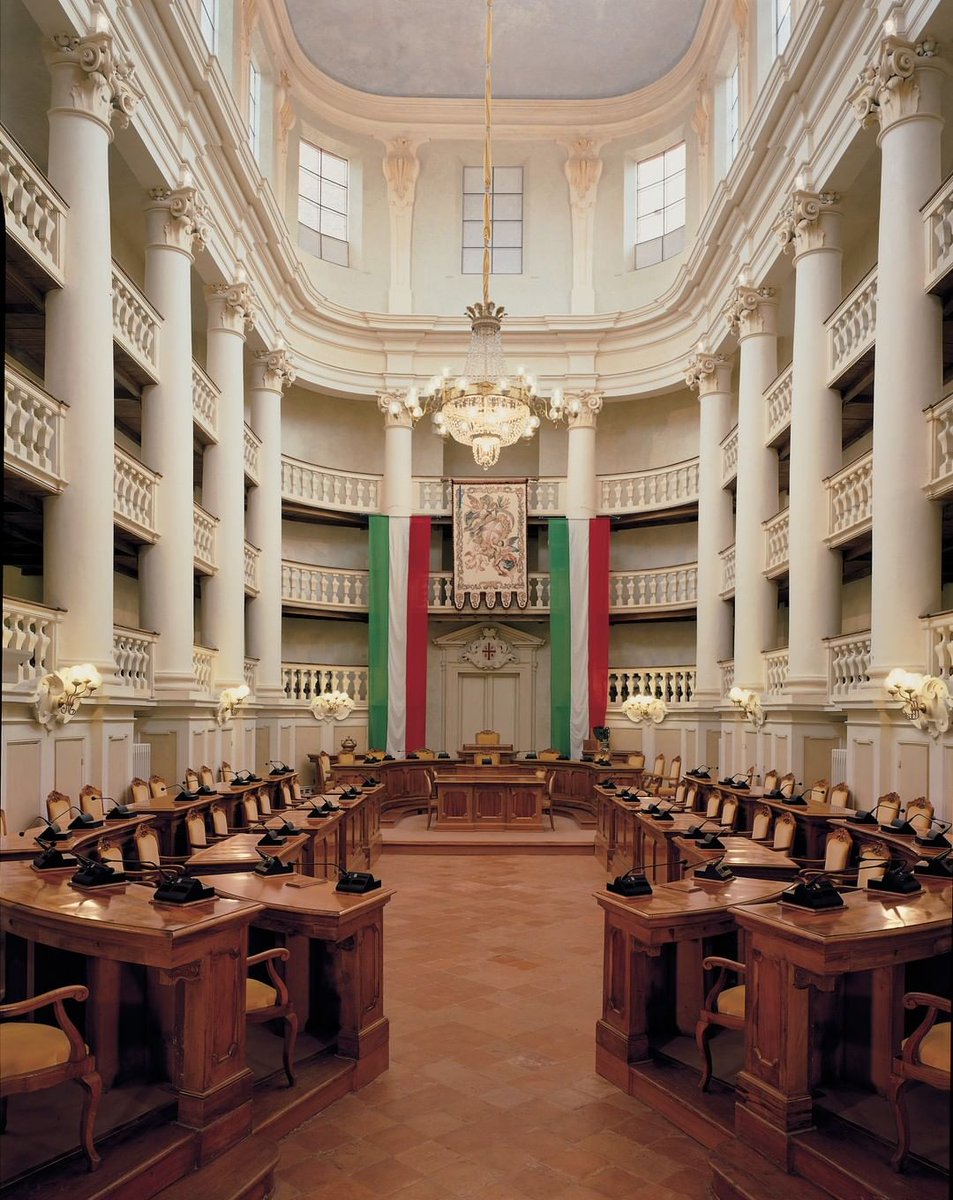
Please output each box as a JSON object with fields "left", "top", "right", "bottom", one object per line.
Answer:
{"left": 380, "top": 0, "right": 568, "bottom": 470}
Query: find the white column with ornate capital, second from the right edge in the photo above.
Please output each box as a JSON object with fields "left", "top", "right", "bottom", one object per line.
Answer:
{"left": 779, "top": 188, "right": 841, "bottom": 703}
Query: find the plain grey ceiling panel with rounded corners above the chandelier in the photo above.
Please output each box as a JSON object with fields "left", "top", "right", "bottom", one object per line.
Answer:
{"left": 286, "top": 0, "right": 705, "bottom": 100}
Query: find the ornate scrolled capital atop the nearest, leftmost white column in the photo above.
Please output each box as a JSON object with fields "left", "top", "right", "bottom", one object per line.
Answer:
{"left": 46, "top": 16, "right": 143, "bottom": 130}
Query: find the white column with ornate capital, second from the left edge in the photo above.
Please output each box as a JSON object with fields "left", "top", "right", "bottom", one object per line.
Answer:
{"left": 139, "top": 175, "right": 208, "bottom": 698}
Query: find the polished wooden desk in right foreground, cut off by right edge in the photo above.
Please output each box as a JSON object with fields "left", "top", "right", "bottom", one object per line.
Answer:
{"left": 732, "top": 887, "right": 953, "bottom": 1166}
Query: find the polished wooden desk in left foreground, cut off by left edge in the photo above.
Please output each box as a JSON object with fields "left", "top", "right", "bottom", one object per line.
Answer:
{"left": 0, "top": 863, "right": 259, "bottom": 1156}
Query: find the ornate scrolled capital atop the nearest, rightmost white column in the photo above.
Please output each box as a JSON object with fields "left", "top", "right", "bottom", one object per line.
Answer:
{"left": 847, "top": 34, "right": 939, "bottom": 132}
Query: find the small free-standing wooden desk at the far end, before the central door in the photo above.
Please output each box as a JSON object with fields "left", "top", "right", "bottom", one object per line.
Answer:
{"left": 434, "top": 767, "right": 546, "bottom": 829}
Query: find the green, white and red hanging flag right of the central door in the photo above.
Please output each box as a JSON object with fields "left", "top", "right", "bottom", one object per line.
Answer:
{"left": 549, "top": 517, "right": 609, "bottom": 758}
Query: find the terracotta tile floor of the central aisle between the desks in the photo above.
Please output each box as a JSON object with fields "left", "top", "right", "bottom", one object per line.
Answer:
{"left": 276, "top": 853, "right": 708, "bottom": 1200}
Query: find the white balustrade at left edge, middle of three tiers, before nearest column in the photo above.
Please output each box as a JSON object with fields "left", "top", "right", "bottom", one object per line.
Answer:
{"left": 4, "top": 359, "right": 66, "bottom": 492}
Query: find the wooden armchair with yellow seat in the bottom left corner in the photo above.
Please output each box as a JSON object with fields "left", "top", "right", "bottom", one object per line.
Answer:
{"left": 0, "top": 984, "right": 102, "bottom": 1171}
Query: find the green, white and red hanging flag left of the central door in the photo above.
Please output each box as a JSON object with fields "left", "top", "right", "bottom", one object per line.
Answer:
{"left": 367, "top": 516, "right": 430, "bottom": 757}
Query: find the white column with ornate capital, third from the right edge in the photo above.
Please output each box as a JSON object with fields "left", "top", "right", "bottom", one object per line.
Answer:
{"left": 726, "top": 282, "right": 778, "bottom": 692}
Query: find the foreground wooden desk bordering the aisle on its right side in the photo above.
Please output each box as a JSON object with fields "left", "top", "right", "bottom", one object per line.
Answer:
{"left": 595, "top": 880, "right": 783, "bottom": 1094}
